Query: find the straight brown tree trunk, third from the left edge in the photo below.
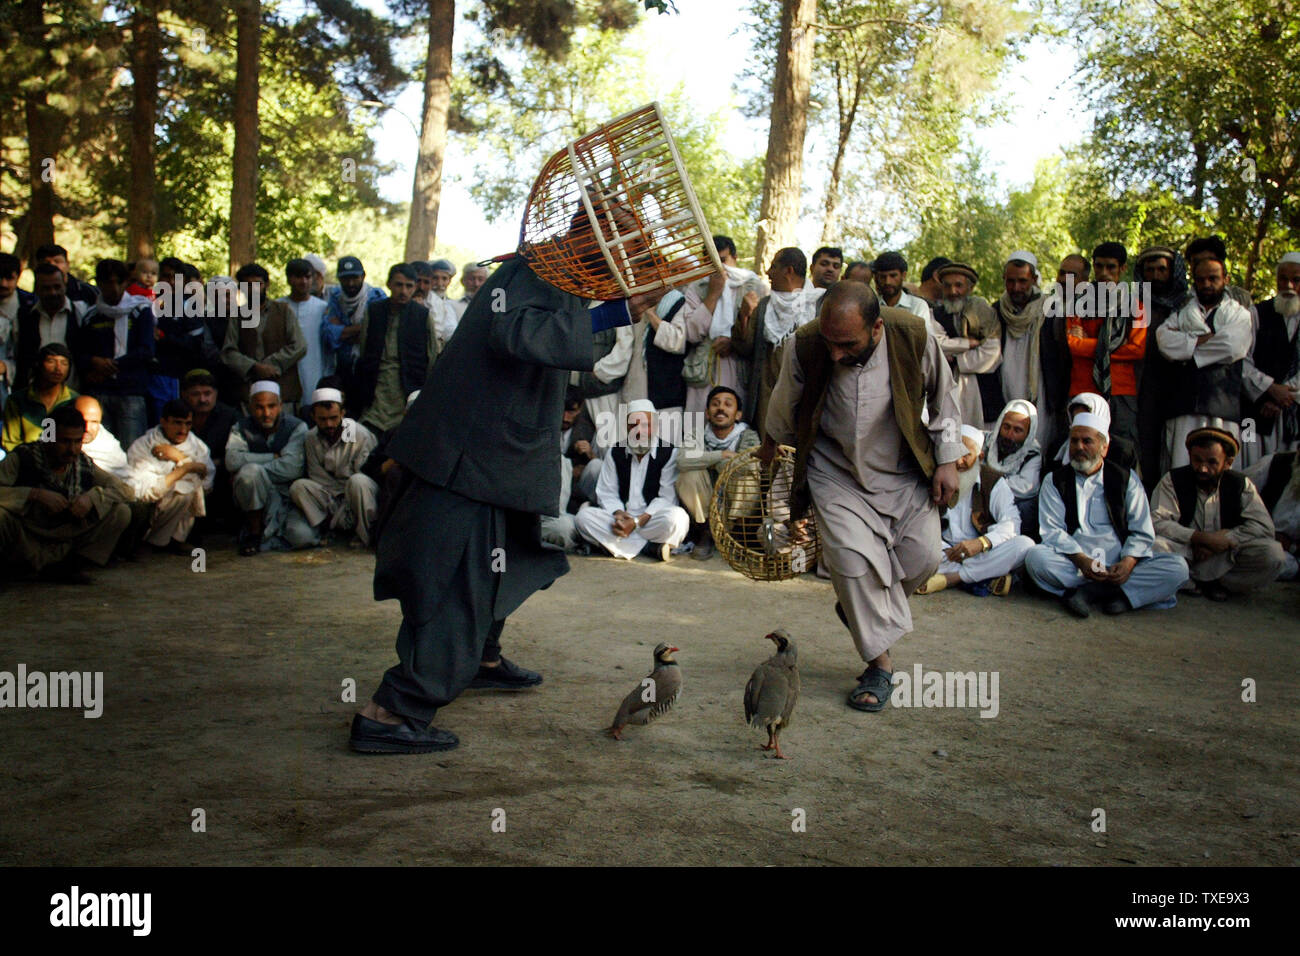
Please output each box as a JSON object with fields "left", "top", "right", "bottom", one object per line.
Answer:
{"left": 230, "top": 0, "right": 261, "bottom": 274}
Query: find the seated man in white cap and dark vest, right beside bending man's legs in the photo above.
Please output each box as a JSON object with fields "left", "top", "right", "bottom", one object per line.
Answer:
{"left": 917, "top": 424, "right": 1034, "bottom": 597}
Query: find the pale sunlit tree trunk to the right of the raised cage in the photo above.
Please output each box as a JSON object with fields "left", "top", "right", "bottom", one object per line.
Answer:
{"left": 754, "top": 0, "right": 816, "bottom": 273}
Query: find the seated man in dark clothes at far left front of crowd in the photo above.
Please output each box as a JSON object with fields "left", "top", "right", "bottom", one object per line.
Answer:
{"left": 0, "top": 403, "right": 131, "bottom": 584}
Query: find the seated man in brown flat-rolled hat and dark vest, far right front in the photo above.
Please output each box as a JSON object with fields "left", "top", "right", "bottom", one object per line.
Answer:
{"left": 1151, "top": 419, "right": 1284, "bottom": 601}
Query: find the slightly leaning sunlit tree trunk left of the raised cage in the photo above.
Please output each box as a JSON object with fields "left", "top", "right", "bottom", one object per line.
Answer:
{"left": 406, "top": 0, "right": 456, "bottom": 263}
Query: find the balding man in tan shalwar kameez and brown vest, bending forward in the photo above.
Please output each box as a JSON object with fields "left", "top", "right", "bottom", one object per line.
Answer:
{"left": 759, "top": 282, "right": 966, "bottom": 711}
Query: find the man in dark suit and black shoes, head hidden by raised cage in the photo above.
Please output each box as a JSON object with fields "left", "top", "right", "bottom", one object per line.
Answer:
{"left": 351, "top": 258, "right": 644, "bottom": 753}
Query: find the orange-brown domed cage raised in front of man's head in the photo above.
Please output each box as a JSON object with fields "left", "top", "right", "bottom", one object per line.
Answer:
{"left": 519, "top": 103, "right": 723, "bottom": 299}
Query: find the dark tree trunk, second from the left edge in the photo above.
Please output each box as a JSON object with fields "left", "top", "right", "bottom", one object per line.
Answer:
{"left": 126, "top": 0, "right": 160, "bottom": 259}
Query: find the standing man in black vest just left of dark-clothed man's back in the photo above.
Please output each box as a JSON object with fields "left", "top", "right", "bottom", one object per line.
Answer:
{"left": 356, "top": 265, "right": 438, "bottom": 438}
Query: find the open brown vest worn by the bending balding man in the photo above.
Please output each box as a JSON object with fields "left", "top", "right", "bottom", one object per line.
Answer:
{"left": 790, "top": 306, "right": 935, "bottom": 520}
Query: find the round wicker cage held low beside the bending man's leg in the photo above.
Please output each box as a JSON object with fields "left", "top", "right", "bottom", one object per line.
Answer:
{"left": 709, "top": 445, "right": 820, "bottom": 581}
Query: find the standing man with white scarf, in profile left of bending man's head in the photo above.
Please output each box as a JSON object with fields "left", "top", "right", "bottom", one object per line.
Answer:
{"left": 731, "top": 246, "right": 826, "bottom": 434}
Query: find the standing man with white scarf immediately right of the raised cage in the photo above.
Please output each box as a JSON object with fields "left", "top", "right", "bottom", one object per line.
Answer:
{"left": 685, "top": 235, "right": 767, "bottom": 415}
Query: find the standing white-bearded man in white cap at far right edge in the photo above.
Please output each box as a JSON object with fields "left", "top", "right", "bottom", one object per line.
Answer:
{"left": 1243, "top": 252, "right": 1300, "bottom": 455}
